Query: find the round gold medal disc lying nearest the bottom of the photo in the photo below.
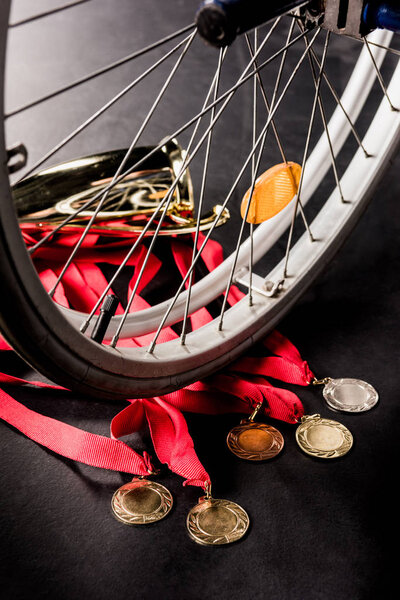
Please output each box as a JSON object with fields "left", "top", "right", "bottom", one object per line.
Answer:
{"left": 186, "top": 498, "right": 250, "bottom": 546}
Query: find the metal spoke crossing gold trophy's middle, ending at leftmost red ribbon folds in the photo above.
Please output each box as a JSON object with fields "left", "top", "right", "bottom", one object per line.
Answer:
{"left": 49, "top": 31, "right": 196, "bottom": 297}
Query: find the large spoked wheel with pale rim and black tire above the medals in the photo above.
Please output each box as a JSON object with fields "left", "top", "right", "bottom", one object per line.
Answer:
{"left": 0, "top": 0, "right": 400, "bottom": 398}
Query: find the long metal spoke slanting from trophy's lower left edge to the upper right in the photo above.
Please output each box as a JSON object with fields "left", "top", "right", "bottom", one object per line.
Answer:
{"left": 29, "top": 24, "right": 306, "bottom": 254}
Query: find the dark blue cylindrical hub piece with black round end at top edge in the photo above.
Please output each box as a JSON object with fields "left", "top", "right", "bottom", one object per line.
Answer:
{"left": 196, "top": 0, "right": 308, "bottom": 47}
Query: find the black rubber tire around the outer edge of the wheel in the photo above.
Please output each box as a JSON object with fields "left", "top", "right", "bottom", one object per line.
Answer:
{"left": 0, "top": 0, "right": 395, "bottom": 400}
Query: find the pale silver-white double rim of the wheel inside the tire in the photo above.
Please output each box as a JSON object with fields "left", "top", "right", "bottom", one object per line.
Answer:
{"left": 60, "top": 30, "right": 400, "bottom": 342}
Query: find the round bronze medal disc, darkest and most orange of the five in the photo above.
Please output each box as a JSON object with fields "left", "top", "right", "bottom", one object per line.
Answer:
{"left": 226, "top": 422, "right": 284, "bottom": 460}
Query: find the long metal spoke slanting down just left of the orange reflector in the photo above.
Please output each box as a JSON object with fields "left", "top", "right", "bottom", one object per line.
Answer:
{"left": 147, "top": 28, "right": 320, "bottom": 354}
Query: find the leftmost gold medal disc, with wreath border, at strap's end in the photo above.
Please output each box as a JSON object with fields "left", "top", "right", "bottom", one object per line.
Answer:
{"left": 111, "top": 479, "right": 173, "bottom": 525}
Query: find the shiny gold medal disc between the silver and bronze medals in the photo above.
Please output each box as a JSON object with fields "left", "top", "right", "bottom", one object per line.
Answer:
{"left": 296, "top": 415, "right": 353, "bottom": 458}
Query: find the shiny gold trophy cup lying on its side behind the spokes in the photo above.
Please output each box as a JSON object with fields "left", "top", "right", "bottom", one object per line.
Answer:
{"left": 13, "top": 140, "right": 229, "bottom": 238}
